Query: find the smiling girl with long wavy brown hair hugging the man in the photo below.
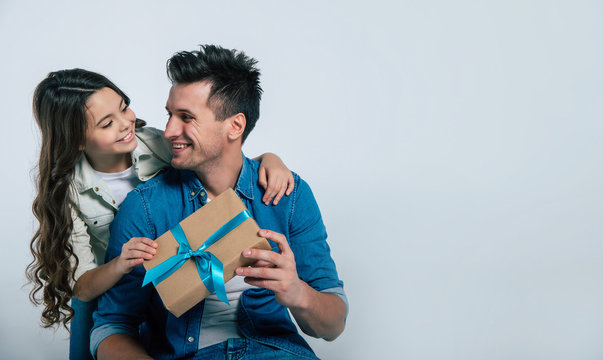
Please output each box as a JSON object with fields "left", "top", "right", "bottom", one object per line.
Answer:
{"left": 27, "top": 69, "right": 293, "bottom": 359}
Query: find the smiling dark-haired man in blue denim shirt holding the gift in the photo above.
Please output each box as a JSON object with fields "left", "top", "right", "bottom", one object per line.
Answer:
{"left": 91, "top": 46, "right": 347, "bottom": 359}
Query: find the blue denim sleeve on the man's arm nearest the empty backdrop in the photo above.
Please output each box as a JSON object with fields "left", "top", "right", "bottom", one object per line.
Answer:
{"left": 288, "top": 175, "right": 348, "bottom": 307}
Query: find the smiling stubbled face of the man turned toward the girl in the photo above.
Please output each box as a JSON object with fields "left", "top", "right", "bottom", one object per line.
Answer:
{"left": 164, "top": 81, "right": 227, "bottom": 171}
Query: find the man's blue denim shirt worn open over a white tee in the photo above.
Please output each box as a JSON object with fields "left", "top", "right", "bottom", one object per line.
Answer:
{"left": 90, "top": 156, "right": 347, "bottom": 359}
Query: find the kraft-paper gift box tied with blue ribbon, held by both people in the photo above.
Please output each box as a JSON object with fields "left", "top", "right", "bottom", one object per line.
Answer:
{"left": 143, "top": 189, "right": 271, "bottom": 317}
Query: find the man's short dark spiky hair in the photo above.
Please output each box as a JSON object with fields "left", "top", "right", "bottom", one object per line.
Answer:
{"left": 167, "top": 45, "right": 262, "bottom": 142}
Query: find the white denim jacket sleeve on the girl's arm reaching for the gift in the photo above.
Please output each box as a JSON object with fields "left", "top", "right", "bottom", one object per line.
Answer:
{"left": 69, "top": 208, "right": 98, "bottom": 289}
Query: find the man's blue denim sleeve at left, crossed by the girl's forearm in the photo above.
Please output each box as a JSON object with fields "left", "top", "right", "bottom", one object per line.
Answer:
{"left": 90, "top": 190, "right": 155, "bottom": 357}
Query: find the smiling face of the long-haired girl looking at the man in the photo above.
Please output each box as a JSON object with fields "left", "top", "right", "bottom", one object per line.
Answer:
{"left": 85, "top": 87, "right": 138, "bottom": 172}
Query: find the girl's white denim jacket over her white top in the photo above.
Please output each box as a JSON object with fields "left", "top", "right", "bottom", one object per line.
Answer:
{"left": 70, "top": 127, "right": 172, "bottom": 286}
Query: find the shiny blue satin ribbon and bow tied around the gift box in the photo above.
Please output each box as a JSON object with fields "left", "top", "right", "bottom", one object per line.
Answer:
{"left": 142, "top": 210, "right": 251, "bottom": 305}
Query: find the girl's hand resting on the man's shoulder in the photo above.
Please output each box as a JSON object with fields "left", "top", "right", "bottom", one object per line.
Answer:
{"left": 258, "top": 153, "right": 294, "bottom": 205}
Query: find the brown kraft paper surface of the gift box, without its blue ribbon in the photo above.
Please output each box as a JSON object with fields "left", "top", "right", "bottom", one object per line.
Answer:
{"left": 144, "top": 189, "right": 271, "bottom": 317}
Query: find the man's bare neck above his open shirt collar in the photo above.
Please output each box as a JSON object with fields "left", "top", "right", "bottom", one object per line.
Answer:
{"left": 195, "top": 149, "right": 243, "bottom": 199}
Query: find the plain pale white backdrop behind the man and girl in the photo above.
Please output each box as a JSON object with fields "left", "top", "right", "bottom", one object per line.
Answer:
{"left": 0, "top": 0, "right": 603, "bottom": 360}
